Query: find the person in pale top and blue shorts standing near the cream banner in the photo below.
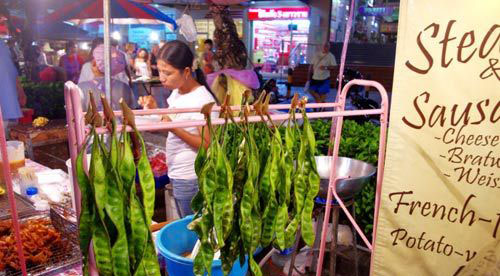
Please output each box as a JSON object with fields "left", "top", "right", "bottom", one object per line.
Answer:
{"left": 309, "top": 42, "right": 337, "bottom": 107}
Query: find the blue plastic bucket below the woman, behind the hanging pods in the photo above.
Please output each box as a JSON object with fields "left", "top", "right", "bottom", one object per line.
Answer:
{"left": 156, "top": 216, "right": 248, "bottom": 276}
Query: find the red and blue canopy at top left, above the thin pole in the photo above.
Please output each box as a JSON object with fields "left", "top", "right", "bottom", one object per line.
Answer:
{"left": 42, "top": 0, "right": 177, "bottom": 29}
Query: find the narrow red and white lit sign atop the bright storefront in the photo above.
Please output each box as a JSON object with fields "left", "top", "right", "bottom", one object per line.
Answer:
{"left": 248, "top": 7, "right": 309, "bottom": 20}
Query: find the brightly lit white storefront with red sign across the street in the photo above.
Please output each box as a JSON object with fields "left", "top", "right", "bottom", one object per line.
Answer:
{"left": 248, "top": 6, "right": 310, "bottom": 72}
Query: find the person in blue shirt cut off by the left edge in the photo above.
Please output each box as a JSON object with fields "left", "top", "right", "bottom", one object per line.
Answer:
{"left": 0, "top": 39, "right": 26, "bottom": 139}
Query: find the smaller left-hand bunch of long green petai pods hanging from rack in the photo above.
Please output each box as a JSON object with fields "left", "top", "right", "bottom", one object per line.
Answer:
{"left": 75, "top": 94, "right": 160, "bottom": 276}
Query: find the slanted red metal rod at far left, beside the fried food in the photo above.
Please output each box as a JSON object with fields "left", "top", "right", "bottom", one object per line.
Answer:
{"left": 0, "top": 108, "right": 28, "bottom": 276}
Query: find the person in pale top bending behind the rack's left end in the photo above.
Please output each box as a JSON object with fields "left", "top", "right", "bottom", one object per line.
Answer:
{"left": 78, "top": 44, "right": 135, "bottom": 111}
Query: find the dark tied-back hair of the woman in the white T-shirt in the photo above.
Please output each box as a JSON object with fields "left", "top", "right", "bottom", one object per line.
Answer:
{"left": 158, "top": 40, "right": 219, "bottom": 104}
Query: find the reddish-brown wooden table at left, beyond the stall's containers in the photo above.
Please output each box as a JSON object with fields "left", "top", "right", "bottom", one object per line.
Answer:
{"left": 10, "top": 120, "right": 68, "bottom": 160}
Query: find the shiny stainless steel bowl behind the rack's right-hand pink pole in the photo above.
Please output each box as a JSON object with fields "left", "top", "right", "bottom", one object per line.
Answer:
{"left": 315, "top": 156, "right": 377, "bottom": 199}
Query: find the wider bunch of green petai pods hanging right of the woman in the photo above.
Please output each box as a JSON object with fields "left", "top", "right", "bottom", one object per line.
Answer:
{"left": 188, "top": 97, "right": 320, "bottom": 276}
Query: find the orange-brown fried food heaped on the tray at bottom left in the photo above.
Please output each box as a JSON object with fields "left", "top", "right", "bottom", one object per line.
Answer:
{"left": 0, "top": 218, "right": 67, "bottom": 271}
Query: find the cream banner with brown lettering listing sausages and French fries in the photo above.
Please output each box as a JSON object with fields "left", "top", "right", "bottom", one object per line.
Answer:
{"left": 371, "top": 0, "right": 500, "bottom": 276}
